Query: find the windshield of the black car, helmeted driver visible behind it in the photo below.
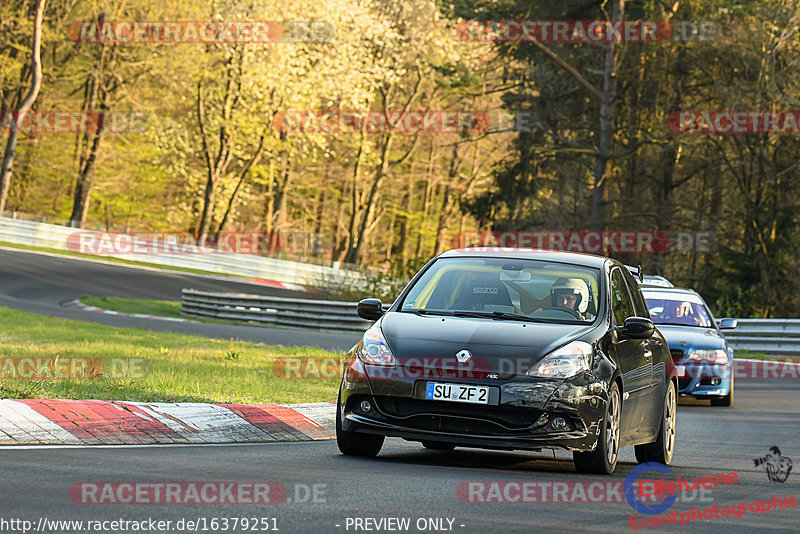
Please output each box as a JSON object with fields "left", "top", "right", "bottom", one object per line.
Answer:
{"left": 400, "top": 258, "right": 599, "bottom": 324}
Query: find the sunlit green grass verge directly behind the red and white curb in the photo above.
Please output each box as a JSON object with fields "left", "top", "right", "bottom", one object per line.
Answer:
{"left": 0, "top": 307, "right": 343, "bottom": 404}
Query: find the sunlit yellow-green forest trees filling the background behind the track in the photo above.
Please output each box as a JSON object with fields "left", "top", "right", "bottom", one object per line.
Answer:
{"left": 0, "top": 0, "right": 800, "bottom": 316}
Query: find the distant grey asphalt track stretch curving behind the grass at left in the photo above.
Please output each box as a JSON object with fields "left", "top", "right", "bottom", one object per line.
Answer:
{"left": 0, "top": 248, "right": 359, "bottom": 350}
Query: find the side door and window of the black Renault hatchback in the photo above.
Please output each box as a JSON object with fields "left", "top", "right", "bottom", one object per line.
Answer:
{"left": 611, "top": 267, "right": 653, "bottom": 436}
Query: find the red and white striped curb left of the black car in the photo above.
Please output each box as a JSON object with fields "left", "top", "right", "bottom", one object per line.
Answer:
{"left": 0, "top": 399, "right": 336, "bottom": 445}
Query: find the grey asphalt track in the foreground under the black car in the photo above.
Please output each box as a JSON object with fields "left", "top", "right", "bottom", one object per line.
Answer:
{"left": 0, "top": 380, "right": 800, "bottom": 534}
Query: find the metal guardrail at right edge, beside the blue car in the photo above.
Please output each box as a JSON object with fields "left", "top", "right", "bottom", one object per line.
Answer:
{"left": 723, "top": 319, "right": 800, "bottom": 356}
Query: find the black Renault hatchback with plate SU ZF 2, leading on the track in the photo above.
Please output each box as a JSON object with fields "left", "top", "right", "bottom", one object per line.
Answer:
{"left": 336, "top": 249, "right": 677, "bottom": 474}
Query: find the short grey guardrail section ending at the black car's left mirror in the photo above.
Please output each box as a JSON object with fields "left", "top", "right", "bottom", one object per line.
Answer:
{"left": 181, "top": 289, "right": 382, "bottom": 332}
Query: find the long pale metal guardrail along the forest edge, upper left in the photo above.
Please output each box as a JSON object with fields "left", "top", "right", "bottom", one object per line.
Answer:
{"left": 0, "top": 217, "right": 363, "bottom": 287}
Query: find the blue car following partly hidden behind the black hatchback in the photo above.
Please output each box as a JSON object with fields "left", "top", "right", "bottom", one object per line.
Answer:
{"left": 641, "top": 284, "right": 736, "bottom": 406}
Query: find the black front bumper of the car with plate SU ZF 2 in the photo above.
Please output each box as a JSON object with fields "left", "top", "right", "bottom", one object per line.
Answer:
{"left": 338, "top": 359, "right": 608, "bottom": 451}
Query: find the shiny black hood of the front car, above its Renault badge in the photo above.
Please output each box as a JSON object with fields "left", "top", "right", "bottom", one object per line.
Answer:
{"left": 380, "top": 312, "right": 594, "bottom": 369}
